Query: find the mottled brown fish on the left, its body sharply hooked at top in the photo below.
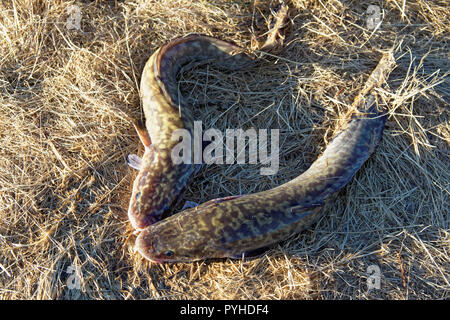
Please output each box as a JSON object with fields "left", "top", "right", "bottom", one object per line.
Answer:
{"left": 128, "top": 34, "right": 255, "bottom": 231}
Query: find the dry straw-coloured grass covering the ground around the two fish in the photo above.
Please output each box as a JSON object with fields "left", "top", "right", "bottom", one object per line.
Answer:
{"left": 0, "top": 0, "right": 450, "bottom": 299}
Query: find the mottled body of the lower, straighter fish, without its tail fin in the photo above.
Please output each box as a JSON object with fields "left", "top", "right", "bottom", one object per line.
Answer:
{"left": 136, "top": 102, "right": 386, "bottom": 262}
